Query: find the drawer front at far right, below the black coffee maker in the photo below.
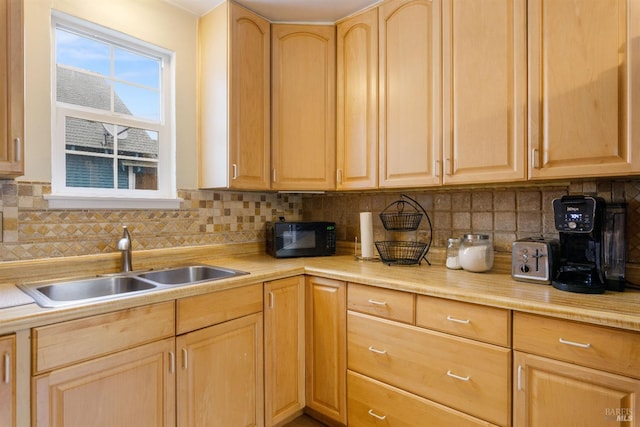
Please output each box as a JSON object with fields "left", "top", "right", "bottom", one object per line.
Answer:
{"left": 513, "top": 312, "right": 640, "bottom": 378}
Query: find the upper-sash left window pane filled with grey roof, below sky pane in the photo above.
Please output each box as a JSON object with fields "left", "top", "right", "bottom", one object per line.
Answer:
{"left": 56, "top": 66, "right": 111, "bottom": 111}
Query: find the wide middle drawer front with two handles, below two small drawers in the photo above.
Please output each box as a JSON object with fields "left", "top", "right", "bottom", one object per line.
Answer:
{"left": 347, "top": 312, "right": 511, "bottom": 425}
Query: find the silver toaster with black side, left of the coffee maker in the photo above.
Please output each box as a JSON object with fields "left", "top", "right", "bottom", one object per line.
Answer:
{"left": 511, "top": 237, "right": 560, "bottom": 284}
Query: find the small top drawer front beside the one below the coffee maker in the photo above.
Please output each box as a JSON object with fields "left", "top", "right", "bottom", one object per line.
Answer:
{"left": 416, "top": 295, "right": 511, "bottom": 347}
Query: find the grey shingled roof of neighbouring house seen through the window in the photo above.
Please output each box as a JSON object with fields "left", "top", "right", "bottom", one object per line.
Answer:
{"left": 56, "top": 66, "right": 158, "bottom": 158}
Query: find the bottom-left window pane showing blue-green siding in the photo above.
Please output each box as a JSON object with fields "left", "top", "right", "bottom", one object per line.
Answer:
{"left": 66, "top": 153, "right": 113, "bottom": 188}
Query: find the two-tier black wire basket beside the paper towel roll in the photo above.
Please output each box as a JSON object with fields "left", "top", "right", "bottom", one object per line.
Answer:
{"left": 375, "top": 194, "right": 433, "bottom": 265}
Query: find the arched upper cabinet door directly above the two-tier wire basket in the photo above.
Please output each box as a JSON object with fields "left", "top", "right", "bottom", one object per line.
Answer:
{"left": 378, "top": 0, "right": 442, "bottom": 187}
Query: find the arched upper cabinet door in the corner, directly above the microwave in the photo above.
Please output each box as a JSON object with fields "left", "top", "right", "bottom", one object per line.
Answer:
{"left": 271, "top": 24, "right": 336, "bottom": 190}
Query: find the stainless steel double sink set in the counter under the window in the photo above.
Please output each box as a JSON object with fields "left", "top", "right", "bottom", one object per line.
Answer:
{"left": 17, "top": 265, "right": 249, "bottom": 307}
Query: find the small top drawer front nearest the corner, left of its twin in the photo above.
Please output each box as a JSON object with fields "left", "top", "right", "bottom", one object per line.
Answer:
{"left": 347, "top": 283, "right": 415, "bottom": 324}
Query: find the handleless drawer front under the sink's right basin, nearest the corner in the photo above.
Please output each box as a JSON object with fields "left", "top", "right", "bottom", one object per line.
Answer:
{"left": 176, "top": 283, "right": 262, "bottom": 335}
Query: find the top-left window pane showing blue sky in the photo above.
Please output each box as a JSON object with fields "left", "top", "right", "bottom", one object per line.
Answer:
{"left": 56, "top": 28, "right": 111, "bottom": 76}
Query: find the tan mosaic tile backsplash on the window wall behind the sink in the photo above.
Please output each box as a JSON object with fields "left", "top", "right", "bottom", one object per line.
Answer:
{"left": 0, "top": 181, "right": 302, "bottom": 261}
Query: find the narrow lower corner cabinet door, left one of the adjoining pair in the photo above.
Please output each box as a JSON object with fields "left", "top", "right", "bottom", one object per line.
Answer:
{"left": 264, "top": 276, "right": 305, "bottom": 426}
